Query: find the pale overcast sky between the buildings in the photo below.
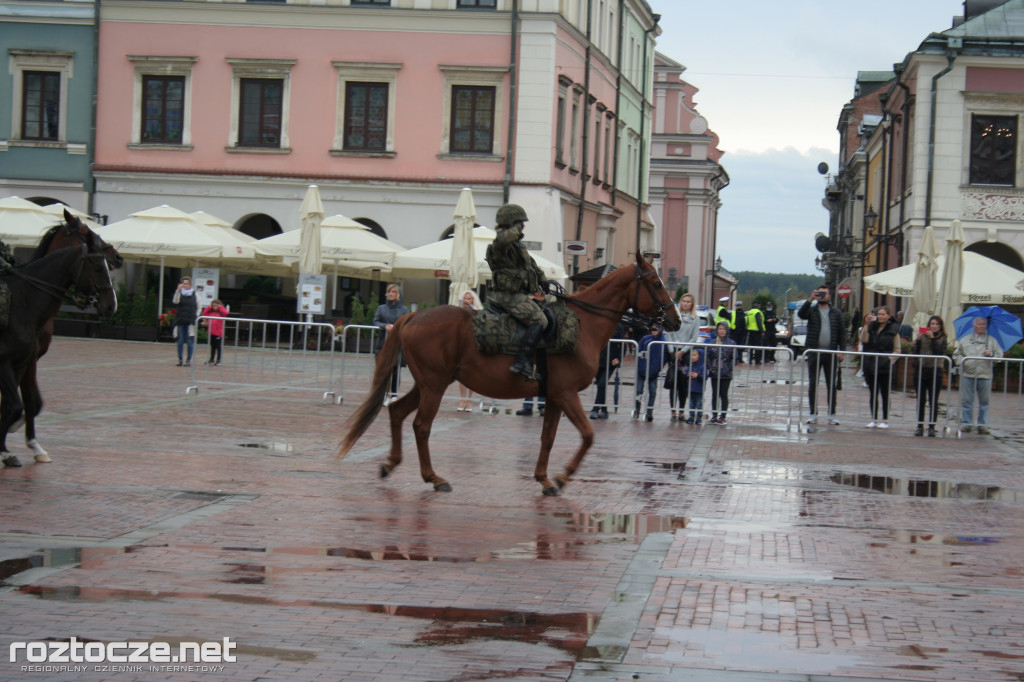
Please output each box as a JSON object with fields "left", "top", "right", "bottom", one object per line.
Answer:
{"left": 648, "top": 0, "right": 964, "bottom": 273}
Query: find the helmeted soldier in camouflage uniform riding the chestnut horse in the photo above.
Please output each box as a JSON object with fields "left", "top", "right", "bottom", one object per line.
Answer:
{"left": 486, "top": 204, "right": 548, "bottom": 381}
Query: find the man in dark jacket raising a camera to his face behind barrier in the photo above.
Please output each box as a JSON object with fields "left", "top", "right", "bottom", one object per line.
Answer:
{"left": 797, "top": 285, "right": 846, "bottom": 425}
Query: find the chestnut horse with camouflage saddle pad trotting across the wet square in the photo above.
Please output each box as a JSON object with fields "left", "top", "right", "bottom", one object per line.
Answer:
{"left": 338, "top": 254, "right": 680, "bottom": 495}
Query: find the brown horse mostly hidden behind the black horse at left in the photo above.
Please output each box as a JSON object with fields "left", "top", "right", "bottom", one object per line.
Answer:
{"left": 4, "top": 210, "right": 124, "bottom": 466}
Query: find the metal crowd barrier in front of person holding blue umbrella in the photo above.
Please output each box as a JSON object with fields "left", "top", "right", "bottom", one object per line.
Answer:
{"left": 949, "top": 356, "right": 1024, "bottom": 435}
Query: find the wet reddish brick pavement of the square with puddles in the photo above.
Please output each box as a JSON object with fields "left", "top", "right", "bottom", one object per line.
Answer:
{"left": 0, "top": 338, "right": 1024, "bottom": 682}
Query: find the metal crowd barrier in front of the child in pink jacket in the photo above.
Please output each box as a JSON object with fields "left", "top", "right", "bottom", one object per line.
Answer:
{"left": 185, "top": 315, "right": 341, "bottom": 401}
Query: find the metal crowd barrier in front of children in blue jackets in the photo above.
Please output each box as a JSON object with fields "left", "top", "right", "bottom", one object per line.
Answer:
{"left": 624, "top": 341, "right": 800, "bottom": 429}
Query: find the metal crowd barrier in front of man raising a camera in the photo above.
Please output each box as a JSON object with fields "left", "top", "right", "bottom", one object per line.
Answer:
{"left": 799, "top": 348, "right": 955, "bottom": 435}
